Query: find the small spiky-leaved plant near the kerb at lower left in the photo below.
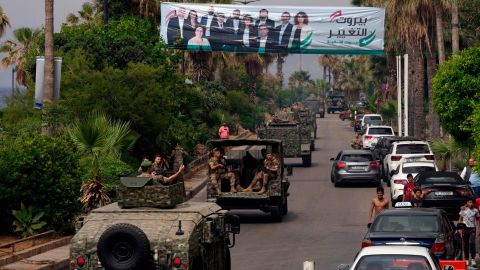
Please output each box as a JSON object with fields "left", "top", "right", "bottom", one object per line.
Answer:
{"left": 12, "top": 203, "right": 47, "bottom": 238}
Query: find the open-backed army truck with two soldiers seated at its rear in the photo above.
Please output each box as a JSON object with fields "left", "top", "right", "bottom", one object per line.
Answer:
{"left": 207, "top": 139, "right": 290, "bottom": 221}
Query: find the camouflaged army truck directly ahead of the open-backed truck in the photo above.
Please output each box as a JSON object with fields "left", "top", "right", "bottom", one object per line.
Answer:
{"left": 257, "top": 119, "right": 312, "bottom": 167}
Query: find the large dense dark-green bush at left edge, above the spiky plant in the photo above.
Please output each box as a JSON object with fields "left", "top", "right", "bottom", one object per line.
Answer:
{"left": 0, "top": 133, "right": 81, "bottom": 232}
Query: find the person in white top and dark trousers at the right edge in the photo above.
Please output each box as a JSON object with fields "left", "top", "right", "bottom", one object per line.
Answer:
{"left": 458, "top": 198, "right": 480, "bottom": 266}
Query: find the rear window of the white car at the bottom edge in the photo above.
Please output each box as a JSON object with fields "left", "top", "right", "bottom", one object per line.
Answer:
{"left": 355, "top": 254, "right": 432, "bottom": 270}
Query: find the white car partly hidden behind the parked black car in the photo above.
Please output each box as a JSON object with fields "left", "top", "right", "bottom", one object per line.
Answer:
{"left": 390, "top": 159, "right": 438, "bottom": 206}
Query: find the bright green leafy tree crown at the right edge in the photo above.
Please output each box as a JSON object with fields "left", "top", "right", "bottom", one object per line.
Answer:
{"left": 433, "top": 48, "right": 480, "bottom": 141}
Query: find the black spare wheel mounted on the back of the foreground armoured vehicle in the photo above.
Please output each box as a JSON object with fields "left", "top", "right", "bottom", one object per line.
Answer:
{"left": 97, "top": 223, "right": 151, "bottom": 270}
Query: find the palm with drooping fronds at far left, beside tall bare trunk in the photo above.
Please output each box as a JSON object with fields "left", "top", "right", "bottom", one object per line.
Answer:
{"left": 0, "top": 27, "right": 42, "bottom": 85}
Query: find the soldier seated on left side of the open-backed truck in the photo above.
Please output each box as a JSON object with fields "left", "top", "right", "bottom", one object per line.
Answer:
{"left": 208, "top": 148, "right": 237, "bottom": 194}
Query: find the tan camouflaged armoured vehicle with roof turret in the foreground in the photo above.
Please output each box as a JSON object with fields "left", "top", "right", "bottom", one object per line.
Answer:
{"left": 70, "top": 177, "right": 240, "bottom": 270}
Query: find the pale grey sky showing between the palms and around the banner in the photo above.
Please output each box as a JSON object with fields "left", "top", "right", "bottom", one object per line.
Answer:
{"left": 0, "top": 0, "right": 350, "bottom": 99}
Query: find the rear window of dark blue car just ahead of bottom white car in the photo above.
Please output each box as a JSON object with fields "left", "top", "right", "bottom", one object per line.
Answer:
{"left": 370, "top": 214, "right": 438, "bottom": 233}
